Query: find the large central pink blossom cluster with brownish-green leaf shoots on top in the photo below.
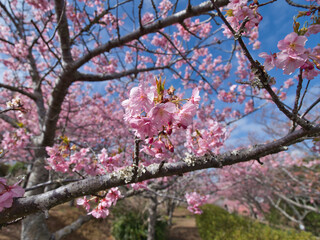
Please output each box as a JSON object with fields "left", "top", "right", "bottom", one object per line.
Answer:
{"left": 122, "top": 79, "right": 200, "bottom": 159}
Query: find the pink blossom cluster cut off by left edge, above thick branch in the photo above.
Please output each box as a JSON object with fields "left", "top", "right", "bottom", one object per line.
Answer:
{"left": 0, "top": 178, "right": 24, "bottom": 212}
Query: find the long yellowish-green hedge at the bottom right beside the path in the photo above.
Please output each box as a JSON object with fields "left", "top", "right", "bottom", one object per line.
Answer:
{"left": 196, "top": 204, "right": 316, "bottom": 240}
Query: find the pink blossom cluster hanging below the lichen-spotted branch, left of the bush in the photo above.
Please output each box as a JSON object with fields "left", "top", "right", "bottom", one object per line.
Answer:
{"left": 77, "top": 187, "right": 123, "bottom": 218}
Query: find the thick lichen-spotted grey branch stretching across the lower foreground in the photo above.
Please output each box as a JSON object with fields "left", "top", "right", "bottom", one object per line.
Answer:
{"left": 0, "top": 125, "right": 320, "bottom": 224}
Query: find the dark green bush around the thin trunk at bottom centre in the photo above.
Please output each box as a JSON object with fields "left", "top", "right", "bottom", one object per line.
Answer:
{"left": 112, "top": 210, "right": 167, "bottom": 240}
